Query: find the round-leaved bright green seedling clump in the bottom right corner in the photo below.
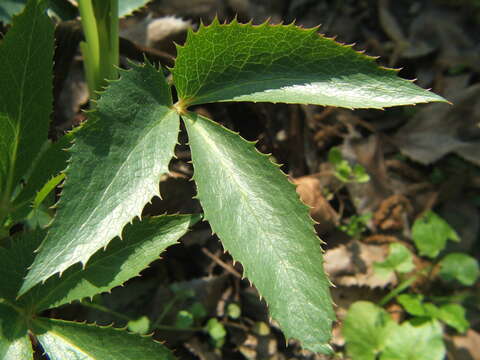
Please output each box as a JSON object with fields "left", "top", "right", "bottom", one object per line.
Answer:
{"left": 343, "top": 211, "right": 479, "bottom": 360}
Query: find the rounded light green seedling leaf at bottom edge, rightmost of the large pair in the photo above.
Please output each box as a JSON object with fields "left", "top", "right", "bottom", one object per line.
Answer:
{"left": 380, "top": 321, "right": 445, "bottom": 360}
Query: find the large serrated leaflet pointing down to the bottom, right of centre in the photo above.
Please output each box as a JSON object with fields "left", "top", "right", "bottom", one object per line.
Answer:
{"left": 183, "top": 113, "right": 334, "bottom": 352}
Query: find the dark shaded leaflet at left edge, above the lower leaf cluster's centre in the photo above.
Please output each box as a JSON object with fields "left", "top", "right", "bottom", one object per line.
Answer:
{"left": 0, "top": 231, "right": 45, "bottom": 302}
